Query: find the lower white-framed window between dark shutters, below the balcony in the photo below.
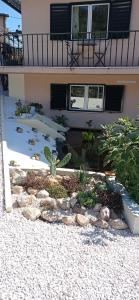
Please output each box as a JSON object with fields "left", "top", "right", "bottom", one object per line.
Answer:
{"left": 69, "top": 85, "right": 104, "bottom": 111}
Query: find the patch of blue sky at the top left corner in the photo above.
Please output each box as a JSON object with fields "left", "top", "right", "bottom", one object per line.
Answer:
{"left": 0, "top": 0, "right": 21, "bottom": 31}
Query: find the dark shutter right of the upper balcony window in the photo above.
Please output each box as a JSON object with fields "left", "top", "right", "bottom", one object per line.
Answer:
{"left": 109, "top": 0, "right": 132, "bottom": 39}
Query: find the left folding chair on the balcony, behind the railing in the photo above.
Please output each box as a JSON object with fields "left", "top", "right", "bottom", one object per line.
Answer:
{"left": 66, "top": 41, "right": 80, "bottom": 68}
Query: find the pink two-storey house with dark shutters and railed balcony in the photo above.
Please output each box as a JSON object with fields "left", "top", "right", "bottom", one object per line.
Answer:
{"left": 0, "top": 0, "right": 139, "bottom": 128}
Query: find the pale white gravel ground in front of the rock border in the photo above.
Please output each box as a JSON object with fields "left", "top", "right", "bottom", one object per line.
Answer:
{"left": 0, "top": 210, "right": 139, "bottom": 300}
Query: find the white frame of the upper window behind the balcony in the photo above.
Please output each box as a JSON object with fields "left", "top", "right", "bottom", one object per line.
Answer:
{"left": 71, "top": 2, "right": 110, "bottom": 39}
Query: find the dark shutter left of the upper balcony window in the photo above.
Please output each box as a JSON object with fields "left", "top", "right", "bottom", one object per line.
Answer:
{"left": 50, "top": 3, "right": 71, "bottom": 40}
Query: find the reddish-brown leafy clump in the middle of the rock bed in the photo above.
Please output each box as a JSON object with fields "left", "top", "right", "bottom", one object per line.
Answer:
{"left": 61, "top": 176, "right": 81, "bottom": 195}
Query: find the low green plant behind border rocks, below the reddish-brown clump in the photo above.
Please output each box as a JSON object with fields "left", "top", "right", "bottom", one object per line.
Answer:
{"left": 77, "top": 191, "right": 98, "bottom": 208}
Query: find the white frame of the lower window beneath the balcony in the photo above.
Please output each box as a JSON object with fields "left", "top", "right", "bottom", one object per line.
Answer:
{"left": 69, "top": 84, "right": 105, "bottom": 112}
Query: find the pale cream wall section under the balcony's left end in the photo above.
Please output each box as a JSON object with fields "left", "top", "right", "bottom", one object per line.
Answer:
{"left": 8, "top": 74, "right": 25, "bottom": 100}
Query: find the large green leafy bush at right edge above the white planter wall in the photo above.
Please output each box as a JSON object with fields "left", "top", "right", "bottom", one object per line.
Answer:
{"left": 100, "top": 118, "right": 139, "bottom": 203}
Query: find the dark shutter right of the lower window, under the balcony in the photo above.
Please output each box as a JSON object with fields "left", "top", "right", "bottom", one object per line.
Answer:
{"left": 105, "top": 85, "right": 124, "bottom": 112}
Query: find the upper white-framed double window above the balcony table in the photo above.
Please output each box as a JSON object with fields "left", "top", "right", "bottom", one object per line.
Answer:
{"left": 72, "top": 4, "right": 110, "bottom": 39}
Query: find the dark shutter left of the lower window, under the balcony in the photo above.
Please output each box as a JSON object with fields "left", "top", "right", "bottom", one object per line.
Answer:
{"left": 51, "top": 84, "right": 67, "bottom": 110}
